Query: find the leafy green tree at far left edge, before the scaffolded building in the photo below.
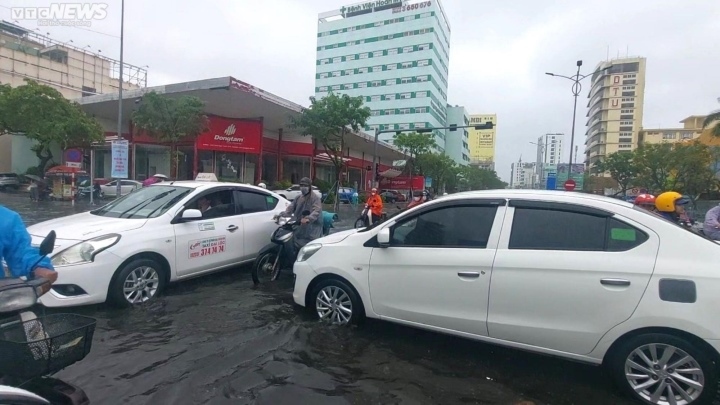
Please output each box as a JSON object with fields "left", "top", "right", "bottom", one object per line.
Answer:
{"left": 0, "top": 79, "right": 104, "bottom": 173}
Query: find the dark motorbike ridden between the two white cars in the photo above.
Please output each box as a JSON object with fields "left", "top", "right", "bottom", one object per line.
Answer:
{"left": 252, "top": 211, "right": 310, "bottom": 285}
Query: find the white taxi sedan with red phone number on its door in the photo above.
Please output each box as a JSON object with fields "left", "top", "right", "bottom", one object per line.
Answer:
{"left": 28, "top": 181, "right": 290, "bottom": 307}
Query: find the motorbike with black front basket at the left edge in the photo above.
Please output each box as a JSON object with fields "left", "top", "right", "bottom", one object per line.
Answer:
{"left": 0, "top": 232, "right": 96, "bottom": 405}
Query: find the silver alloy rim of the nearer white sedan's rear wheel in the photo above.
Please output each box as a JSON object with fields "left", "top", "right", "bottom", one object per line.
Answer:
{"left": 625, "top": 343, "right": 705, "bottom": 405}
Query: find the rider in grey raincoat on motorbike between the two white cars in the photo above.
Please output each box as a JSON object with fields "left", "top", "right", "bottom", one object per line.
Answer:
{"left": 276, "top": 177, "right": 323, "bottom": 252}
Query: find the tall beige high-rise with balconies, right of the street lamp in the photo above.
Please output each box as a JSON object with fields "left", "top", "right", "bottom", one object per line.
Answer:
{"left": 584, "top": 57, "right": 646, "bottom": 167}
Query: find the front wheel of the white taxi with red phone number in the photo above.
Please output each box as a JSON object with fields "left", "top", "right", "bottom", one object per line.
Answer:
{"left": 108, "top": 259, "right": 165, "bottom": 307}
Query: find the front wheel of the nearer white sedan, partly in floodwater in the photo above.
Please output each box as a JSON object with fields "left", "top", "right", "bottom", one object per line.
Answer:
{"left": 312, "top": 279, "right": 365, "bottom": 326}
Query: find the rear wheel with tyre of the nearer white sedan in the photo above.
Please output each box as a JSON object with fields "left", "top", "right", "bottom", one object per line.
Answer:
{"left": 610, "top": 333, "right": 718, "bottom": 405}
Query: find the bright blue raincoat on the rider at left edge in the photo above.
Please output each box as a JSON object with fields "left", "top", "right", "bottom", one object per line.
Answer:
{"left": 0, "top": 206, "right": 53, "bottom": 278}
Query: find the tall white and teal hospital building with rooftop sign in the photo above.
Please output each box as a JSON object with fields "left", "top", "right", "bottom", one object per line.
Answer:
{"left": 315, "top": 0, "right": 450, "bottom": 152}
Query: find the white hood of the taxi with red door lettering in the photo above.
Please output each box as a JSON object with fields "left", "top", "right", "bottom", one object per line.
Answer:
{"left": 28, "top": 212, "right": 147, "bottom": 241}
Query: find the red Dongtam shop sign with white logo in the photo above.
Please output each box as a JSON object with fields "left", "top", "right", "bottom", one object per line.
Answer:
{"left": 197, "top": 116, "right": 262, "bottom": 153}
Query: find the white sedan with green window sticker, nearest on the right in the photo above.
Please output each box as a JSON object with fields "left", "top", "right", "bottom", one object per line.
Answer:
{"left": 293, "top": 190, "right": 720, "bottom": 404}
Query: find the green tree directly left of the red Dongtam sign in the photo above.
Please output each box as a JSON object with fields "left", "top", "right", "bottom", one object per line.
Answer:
{"left": 132, "top": 91, "right": 208, "bottom": 177}
